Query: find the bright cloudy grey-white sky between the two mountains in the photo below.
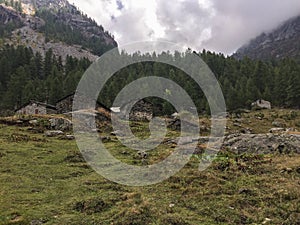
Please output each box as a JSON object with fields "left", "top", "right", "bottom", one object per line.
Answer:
{"left": 70, "top": 0, "right": 300, "bottom": 54}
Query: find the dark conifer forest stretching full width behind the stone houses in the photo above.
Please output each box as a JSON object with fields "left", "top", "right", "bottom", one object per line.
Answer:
{"left": 0, "top": 45, "right": 300, "bottom": 113}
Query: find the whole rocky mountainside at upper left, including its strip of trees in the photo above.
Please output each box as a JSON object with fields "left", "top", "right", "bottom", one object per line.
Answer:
{"left": 0, "top": 0, "right": 117, "bottom": 61}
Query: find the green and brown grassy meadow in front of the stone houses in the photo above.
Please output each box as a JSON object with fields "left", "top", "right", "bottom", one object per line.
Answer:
{"left": 0, "top": 113, "right": 300, "bottom": 225}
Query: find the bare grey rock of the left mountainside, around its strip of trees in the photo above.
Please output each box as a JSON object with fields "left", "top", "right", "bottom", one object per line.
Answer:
{"left": 0, "top": 0, "right": 117, "bottom": 61}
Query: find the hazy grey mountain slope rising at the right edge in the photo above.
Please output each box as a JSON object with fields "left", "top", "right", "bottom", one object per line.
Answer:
{"left": 234, "top": 16, "right": 300, "bottom": 60}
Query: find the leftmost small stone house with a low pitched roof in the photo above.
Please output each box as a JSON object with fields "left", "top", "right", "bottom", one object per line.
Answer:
{"left": 15, "top": 100, "right": 56, "bottom": 115}
